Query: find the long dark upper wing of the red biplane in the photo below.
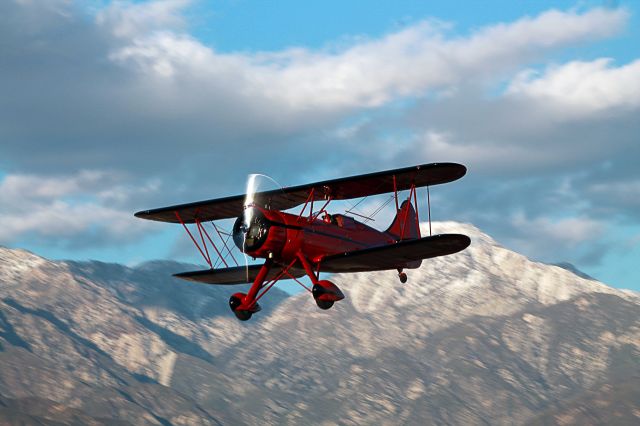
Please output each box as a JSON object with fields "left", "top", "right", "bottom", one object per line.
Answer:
{"left": 135, "top": 163, "right": 467, "bottom": 223}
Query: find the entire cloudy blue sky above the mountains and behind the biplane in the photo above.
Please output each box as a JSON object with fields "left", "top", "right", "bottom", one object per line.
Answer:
{"left": 0, "top": 0, "right": 640, "bottom": 290}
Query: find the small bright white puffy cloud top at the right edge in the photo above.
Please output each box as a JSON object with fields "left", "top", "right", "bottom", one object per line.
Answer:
{"left": 507, "top": 58, "right": 640, "bottom": 118}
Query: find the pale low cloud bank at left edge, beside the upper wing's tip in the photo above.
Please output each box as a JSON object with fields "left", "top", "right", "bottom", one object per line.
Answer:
{"left": 0, "top": 171, "right": 157, "bottom": 246}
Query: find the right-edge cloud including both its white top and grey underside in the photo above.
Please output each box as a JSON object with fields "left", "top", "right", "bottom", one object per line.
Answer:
{"left": 398, "top": 55, "right": 640, "bottom": 178}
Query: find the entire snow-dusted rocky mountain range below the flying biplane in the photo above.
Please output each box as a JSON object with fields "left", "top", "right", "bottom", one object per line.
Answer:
{"left": 0, "top": 223, "right": 640, "bottom": 424}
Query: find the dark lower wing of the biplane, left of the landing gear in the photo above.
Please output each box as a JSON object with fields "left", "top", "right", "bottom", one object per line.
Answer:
{"left": 173, "top": 265, "right": 305, "bottom": 285}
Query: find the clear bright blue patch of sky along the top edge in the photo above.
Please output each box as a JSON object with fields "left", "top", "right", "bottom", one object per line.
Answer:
{"left": 190, "top": 0, "right": 628, "bottom": 52}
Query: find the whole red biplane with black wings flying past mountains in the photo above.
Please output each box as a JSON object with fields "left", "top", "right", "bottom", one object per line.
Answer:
{"left": 135, "top": 163, "right": 471, "bottom": 321}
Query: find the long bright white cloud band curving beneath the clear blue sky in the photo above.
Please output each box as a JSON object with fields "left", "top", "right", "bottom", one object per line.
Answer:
{"left": 106, "top": 5, "right": 627, "bottom": 112}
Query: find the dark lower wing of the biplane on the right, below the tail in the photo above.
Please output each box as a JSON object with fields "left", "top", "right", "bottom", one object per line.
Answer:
{"left": 320, "top": 234, "right": 471, "bottom": 272}
